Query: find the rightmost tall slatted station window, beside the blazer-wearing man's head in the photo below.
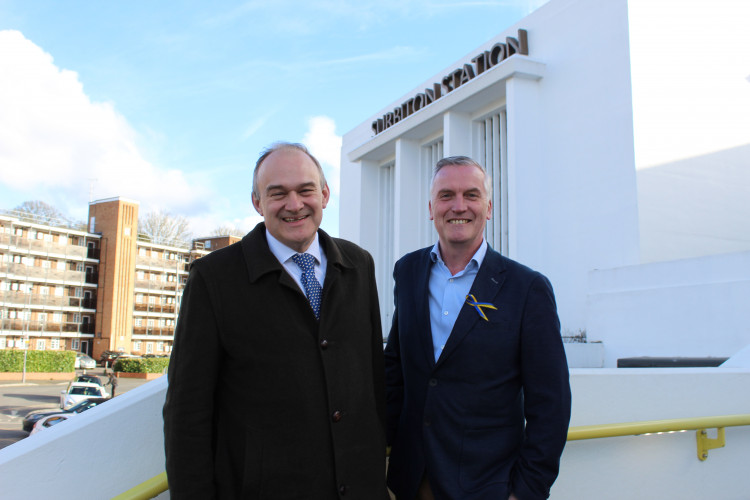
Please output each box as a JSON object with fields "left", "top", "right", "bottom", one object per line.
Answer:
{"left": 473, "top": 110, "right": 508, "bottom": 255}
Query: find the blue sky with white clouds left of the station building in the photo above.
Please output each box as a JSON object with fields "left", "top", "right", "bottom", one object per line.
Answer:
{"left": 0, "top": 0, "right": 544, "bottom": 236}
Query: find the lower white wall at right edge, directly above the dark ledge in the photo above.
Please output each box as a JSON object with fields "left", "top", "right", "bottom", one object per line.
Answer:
{"left": 587, "top": 252, "right": 750, "bottom": 366}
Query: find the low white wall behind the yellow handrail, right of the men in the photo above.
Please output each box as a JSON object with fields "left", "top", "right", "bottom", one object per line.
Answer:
{"left": 550, "top": 366, "right": 750, "bottom": 500}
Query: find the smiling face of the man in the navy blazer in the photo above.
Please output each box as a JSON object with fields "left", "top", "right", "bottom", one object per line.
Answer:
{"left": 430, "top": 165, "right": 492, "bottom": 252}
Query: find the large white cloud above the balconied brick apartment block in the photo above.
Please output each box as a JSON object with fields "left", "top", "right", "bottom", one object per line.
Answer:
{"left": 0, "top": 30, "right": 207, "bottom": 218}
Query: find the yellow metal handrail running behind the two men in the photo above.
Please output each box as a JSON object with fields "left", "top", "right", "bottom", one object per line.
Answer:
{"left": 114, "top": 414, "right": 750, "bottom": 500}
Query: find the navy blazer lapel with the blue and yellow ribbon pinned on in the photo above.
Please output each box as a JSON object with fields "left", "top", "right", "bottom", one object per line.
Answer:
{"left": 438, "top": 247, "right": 505, "bottom": 367}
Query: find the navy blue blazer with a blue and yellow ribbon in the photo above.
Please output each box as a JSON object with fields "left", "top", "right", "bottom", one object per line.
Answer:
{"left": 385, "top": 247, "right": 570, "bottom": 500}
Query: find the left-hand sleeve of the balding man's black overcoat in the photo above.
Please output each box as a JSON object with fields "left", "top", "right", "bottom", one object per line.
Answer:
{"left": 163, "top": 266, "right": 221, "bottom": 499}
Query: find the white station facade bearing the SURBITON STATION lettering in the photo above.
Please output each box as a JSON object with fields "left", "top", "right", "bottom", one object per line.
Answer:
{"left": 340, "top": 0, "right": 639, "bottom": 332}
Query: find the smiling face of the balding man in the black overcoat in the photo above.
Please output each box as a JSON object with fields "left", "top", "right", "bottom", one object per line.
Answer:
{"left": 253, "top": 149, "right": 330, "bottom": 252}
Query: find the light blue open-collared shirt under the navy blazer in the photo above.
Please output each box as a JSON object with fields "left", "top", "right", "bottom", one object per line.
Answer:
{"left": 429, "top": 240, "right": 487, "bottom": 361}
